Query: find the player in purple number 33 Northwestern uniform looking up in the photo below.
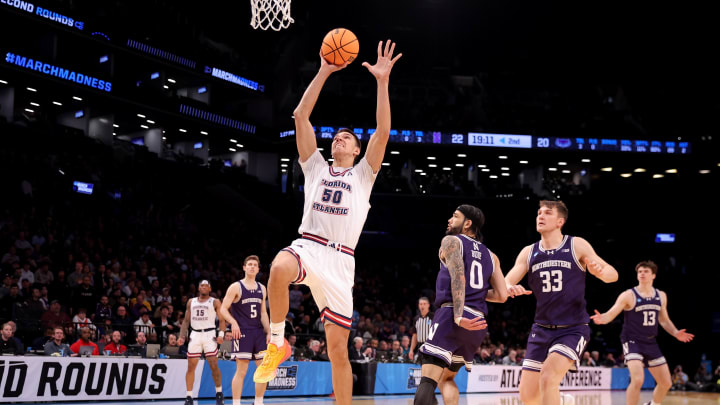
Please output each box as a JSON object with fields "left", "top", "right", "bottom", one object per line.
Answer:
{"left": 505, "top": 201, "right": 618, "bottom": 405}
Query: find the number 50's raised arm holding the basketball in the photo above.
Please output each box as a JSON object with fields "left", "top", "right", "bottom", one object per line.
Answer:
{"left": 293, "top": 54, "right": 347, "bottom": 162}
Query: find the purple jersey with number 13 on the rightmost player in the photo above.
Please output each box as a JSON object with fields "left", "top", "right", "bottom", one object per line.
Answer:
{"left": 620, "top": 288, "right": 662, "bottom": 342}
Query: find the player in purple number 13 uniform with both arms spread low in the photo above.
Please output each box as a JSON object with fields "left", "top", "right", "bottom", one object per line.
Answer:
{"left": 591, "top": 261, "right": 694, "bottom": 405}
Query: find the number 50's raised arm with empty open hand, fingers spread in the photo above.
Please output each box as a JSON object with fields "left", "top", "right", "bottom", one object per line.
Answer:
{"left": 363, "top": 39, "right": 402, "bottom": 173}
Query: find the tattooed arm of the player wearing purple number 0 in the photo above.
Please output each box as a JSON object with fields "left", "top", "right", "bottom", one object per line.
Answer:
{"left": 440, "top": 235, "right": 487, "bottom": 330}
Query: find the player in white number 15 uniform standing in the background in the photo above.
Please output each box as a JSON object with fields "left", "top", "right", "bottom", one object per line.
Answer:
{"left": 178, "top": 280, "right": 225, "bottom": 405}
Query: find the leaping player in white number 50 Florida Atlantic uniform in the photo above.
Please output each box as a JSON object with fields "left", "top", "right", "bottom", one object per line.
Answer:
{"left": 253, "top": 40, "right": 402, "bottom": 405}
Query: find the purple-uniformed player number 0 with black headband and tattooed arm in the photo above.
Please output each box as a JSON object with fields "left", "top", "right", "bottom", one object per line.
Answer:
{"left": 415, "top": 204, "right": 507, "bottom": 405}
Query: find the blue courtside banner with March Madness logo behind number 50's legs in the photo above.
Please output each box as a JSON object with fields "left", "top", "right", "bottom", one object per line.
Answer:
{"left": 196, "top": 360, "right": 333, "bottom": 398}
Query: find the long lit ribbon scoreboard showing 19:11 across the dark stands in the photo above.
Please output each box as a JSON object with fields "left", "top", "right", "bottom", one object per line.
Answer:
{"left": 280, "top": 126, "right": 691, "bottom": 155}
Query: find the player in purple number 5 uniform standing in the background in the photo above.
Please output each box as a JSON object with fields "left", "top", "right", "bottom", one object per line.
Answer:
{"left": 220, "top": 255, "right": 270, "bottom": 404}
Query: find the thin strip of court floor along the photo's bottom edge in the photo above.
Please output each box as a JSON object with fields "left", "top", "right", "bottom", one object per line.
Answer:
{"left": 46, "top": 391, "right": 720, "bottom": 405}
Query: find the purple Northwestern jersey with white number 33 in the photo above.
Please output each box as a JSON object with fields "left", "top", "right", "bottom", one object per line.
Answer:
{"left": 528, "top": 235, "right": 590, "bottom": 325}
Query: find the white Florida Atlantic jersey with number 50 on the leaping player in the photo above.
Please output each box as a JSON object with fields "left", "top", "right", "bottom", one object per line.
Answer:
{"left": 298, "top": 149, "right": 377, "bottom": 249}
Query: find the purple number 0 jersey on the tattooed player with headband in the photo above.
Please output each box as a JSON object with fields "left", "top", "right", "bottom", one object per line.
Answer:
{"left": 435, "top": 234, "right": 495, "bottom": 314}
